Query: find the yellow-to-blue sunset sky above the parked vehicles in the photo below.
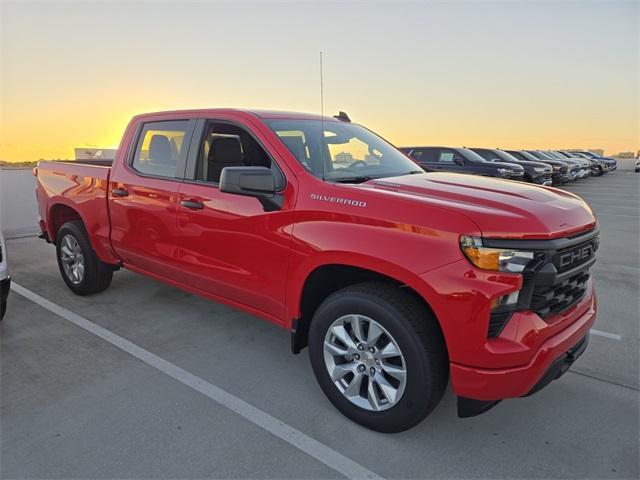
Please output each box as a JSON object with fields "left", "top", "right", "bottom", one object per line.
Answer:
{"left": 0, "top": 1, "right": 640, "bottom": 161}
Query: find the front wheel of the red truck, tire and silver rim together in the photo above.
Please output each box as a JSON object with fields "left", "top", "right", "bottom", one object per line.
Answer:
{"left": 309, "top": 283, "right": 448, "bottom": 432}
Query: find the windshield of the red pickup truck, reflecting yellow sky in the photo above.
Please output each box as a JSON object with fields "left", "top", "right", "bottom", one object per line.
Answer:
{"left": 265, "top": 120, "right": 423, "bottom": 183}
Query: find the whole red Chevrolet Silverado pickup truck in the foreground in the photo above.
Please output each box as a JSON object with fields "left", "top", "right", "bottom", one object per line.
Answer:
{"left": 35, "top": 109, "right": 598, "bottom": 432}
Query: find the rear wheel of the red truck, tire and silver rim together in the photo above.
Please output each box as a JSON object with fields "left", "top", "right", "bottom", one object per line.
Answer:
{"left": 56, "top": 220, "right": 113, "bottom": 295}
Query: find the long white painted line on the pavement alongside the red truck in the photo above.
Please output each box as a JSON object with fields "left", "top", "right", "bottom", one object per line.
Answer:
{"left": 11, "top": 282, "right": 383, "bottom": 480}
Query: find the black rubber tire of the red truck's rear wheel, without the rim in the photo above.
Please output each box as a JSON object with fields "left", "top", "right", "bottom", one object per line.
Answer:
{"left": 56, "top": 220, "right": 113, "bottom": 295}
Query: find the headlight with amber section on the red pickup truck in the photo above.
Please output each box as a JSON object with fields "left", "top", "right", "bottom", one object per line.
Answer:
{"left": 460, "top": 235, "right": 533, "bottom": 273}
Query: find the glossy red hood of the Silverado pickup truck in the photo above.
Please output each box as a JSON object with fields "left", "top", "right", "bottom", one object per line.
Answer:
{"left": 358, "top": 172, "right": 596, "bottom": 239}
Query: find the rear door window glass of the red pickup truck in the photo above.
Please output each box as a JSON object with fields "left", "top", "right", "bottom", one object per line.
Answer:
{"left": 132, "top": 120, "right": 189, "bottom": 178}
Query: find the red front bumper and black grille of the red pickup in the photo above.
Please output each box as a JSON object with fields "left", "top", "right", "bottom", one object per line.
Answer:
{"left": 421, "top": 228, "right": 598, "bottom": 414}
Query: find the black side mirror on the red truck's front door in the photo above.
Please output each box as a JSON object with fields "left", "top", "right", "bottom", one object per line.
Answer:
{"left": 219, "top": 167, "right": 282, "bottom": 211}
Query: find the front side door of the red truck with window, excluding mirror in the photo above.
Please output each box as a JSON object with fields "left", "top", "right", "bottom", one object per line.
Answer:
{"left": 176, "top": 121, "right": 295, "bottom": 322}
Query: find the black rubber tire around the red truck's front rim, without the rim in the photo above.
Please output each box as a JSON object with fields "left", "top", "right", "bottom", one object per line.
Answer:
{"left": 309, "top": 282, "right": 449, "bottom": 433}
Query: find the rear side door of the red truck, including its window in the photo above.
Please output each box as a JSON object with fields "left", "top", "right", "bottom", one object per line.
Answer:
{"left": 109, "top": 119, "right": 195, "bottom": 279}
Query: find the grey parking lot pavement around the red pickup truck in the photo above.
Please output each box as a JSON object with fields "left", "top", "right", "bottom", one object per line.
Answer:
{"left": 0, "top": 171, "right": 640, "bottom": 478}
